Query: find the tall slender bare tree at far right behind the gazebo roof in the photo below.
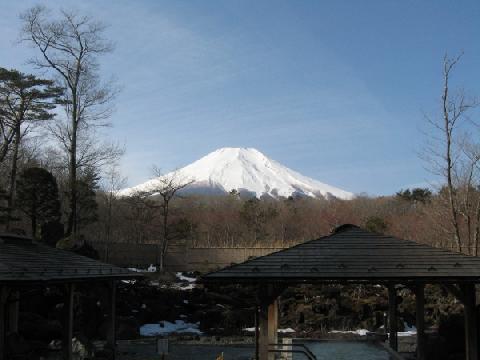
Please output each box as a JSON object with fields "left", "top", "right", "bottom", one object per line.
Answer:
{"left": 425, "top": 54, "right": 480, "bottom": 252}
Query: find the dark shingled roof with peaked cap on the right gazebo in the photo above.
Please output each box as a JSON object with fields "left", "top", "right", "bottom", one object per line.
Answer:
{"left": 203, "top": 224, "right": 480, "bottom": 283}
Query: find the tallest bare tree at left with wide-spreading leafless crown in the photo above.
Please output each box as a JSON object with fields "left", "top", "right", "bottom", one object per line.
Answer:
{"left": 21, "top": 6, "right": 115, "bottom": 238}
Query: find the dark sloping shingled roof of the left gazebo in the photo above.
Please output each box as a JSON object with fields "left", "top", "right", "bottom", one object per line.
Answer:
{"left": 0, "top": 235, "right": 140, "bottom": 284}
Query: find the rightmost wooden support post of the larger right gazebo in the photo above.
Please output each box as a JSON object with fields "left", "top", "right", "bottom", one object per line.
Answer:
{"left": 462, "top": 284, "right": 478, "bottom": 360}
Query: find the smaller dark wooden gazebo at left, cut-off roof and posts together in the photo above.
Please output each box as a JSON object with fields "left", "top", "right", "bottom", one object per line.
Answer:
{"left": 0, "top": 234, "right": 141, "bottom": 360}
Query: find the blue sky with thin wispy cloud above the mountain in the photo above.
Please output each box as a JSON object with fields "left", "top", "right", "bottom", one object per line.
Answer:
{"left": 0, "top": 0, "right": 480, "bottom": 195}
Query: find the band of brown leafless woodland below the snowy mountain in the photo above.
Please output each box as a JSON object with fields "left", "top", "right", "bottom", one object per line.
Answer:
{"left": 87, "top": 189, "right": 455, "bottom": 249}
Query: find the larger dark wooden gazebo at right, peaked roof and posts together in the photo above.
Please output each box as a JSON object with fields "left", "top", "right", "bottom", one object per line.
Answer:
{"left": 203, "top": 224, "right": 480, "bottom": 360}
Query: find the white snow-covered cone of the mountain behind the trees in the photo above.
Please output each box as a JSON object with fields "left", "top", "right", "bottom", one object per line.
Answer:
{"left": 120, "top": 148, "right": 354, "bottom": 200}
